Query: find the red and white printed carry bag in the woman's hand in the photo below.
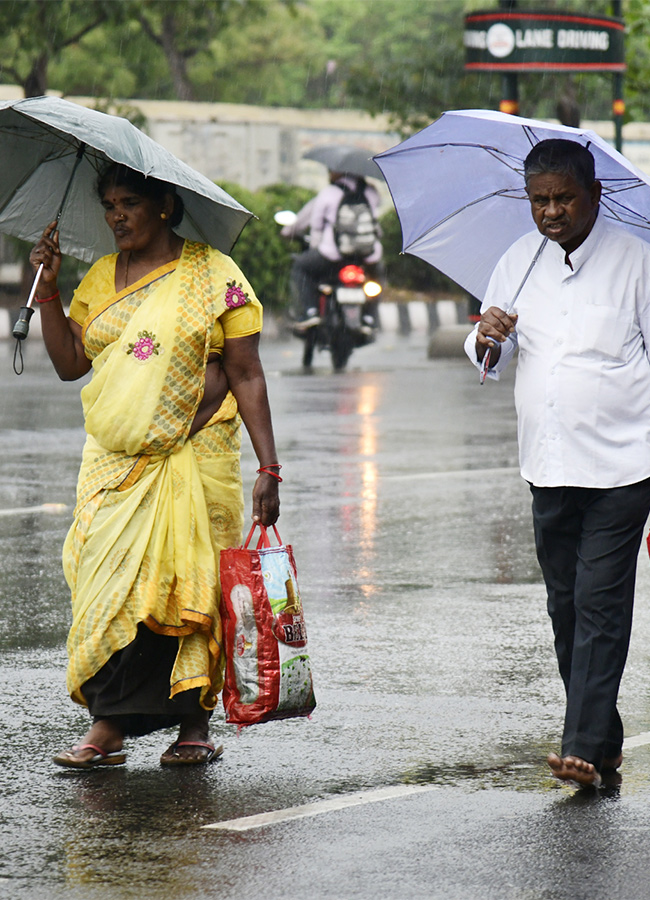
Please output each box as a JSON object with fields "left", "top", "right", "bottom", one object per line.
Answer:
{"left": 220, "top": 526, "right": 316, "bottom": 725}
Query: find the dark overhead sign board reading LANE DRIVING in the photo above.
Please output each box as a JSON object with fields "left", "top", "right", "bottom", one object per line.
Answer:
{"left": 464, "top": 10, "right": 626, "bottom": 72}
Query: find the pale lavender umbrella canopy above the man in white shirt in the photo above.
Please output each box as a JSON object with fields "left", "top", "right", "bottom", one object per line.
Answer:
{"left": 375, "top": 109, "right": 650, "bottom": 299}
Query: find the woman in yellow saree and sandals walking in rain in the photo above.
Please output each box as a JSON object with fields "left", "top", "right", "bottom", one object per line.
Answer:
{"left": 30, "top": 165, "right": 281, "bottom": 768}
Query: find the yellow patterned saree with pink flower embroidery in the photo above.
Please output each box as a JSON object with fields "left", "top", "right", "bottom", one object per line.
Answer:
{"left": 63, "top": 242, "right": 259, "bottom": 709}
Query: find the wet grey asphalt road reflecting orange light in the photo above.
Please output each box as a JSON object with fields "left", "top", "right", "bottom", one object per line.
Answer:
{"left": 0, "top": 335, "right": 650, "bottom": 900}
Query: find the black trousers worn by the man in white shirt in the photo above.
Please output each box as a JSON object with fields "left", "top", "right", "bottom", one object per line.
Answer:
{"left": 531, "top": 478, "right": 650, "bottom": 769}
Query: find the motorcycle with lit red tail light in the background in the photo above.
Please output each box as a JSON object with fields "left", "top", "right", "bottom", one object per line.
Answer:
{"left": 275, "top": 210, "right": 382, "bottom": 372}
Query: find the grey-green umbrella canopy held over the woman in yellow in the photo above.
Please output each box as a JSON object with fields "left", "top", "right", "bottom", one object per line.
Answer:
{"left": 0, "top": 97, "right": 251, "bottom": 262}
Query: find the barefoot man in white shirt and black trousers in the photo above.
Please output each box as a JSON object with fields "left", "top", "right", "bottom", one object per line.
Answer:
{"left": 465, "top": 140, "right": 650, "bottom": 786}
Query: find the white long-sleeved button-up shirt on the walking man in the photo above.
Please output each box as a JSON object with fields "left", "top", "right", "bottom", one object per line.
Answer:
{"left": 465, "top": 214, "right": 650, "bottom": 488}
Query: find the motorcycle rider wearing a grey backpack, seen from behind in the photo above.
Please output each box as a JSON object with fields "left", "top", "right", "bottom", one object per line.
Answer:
{"left": 281, "top": 171, "right": 384, "bottom": 332}
